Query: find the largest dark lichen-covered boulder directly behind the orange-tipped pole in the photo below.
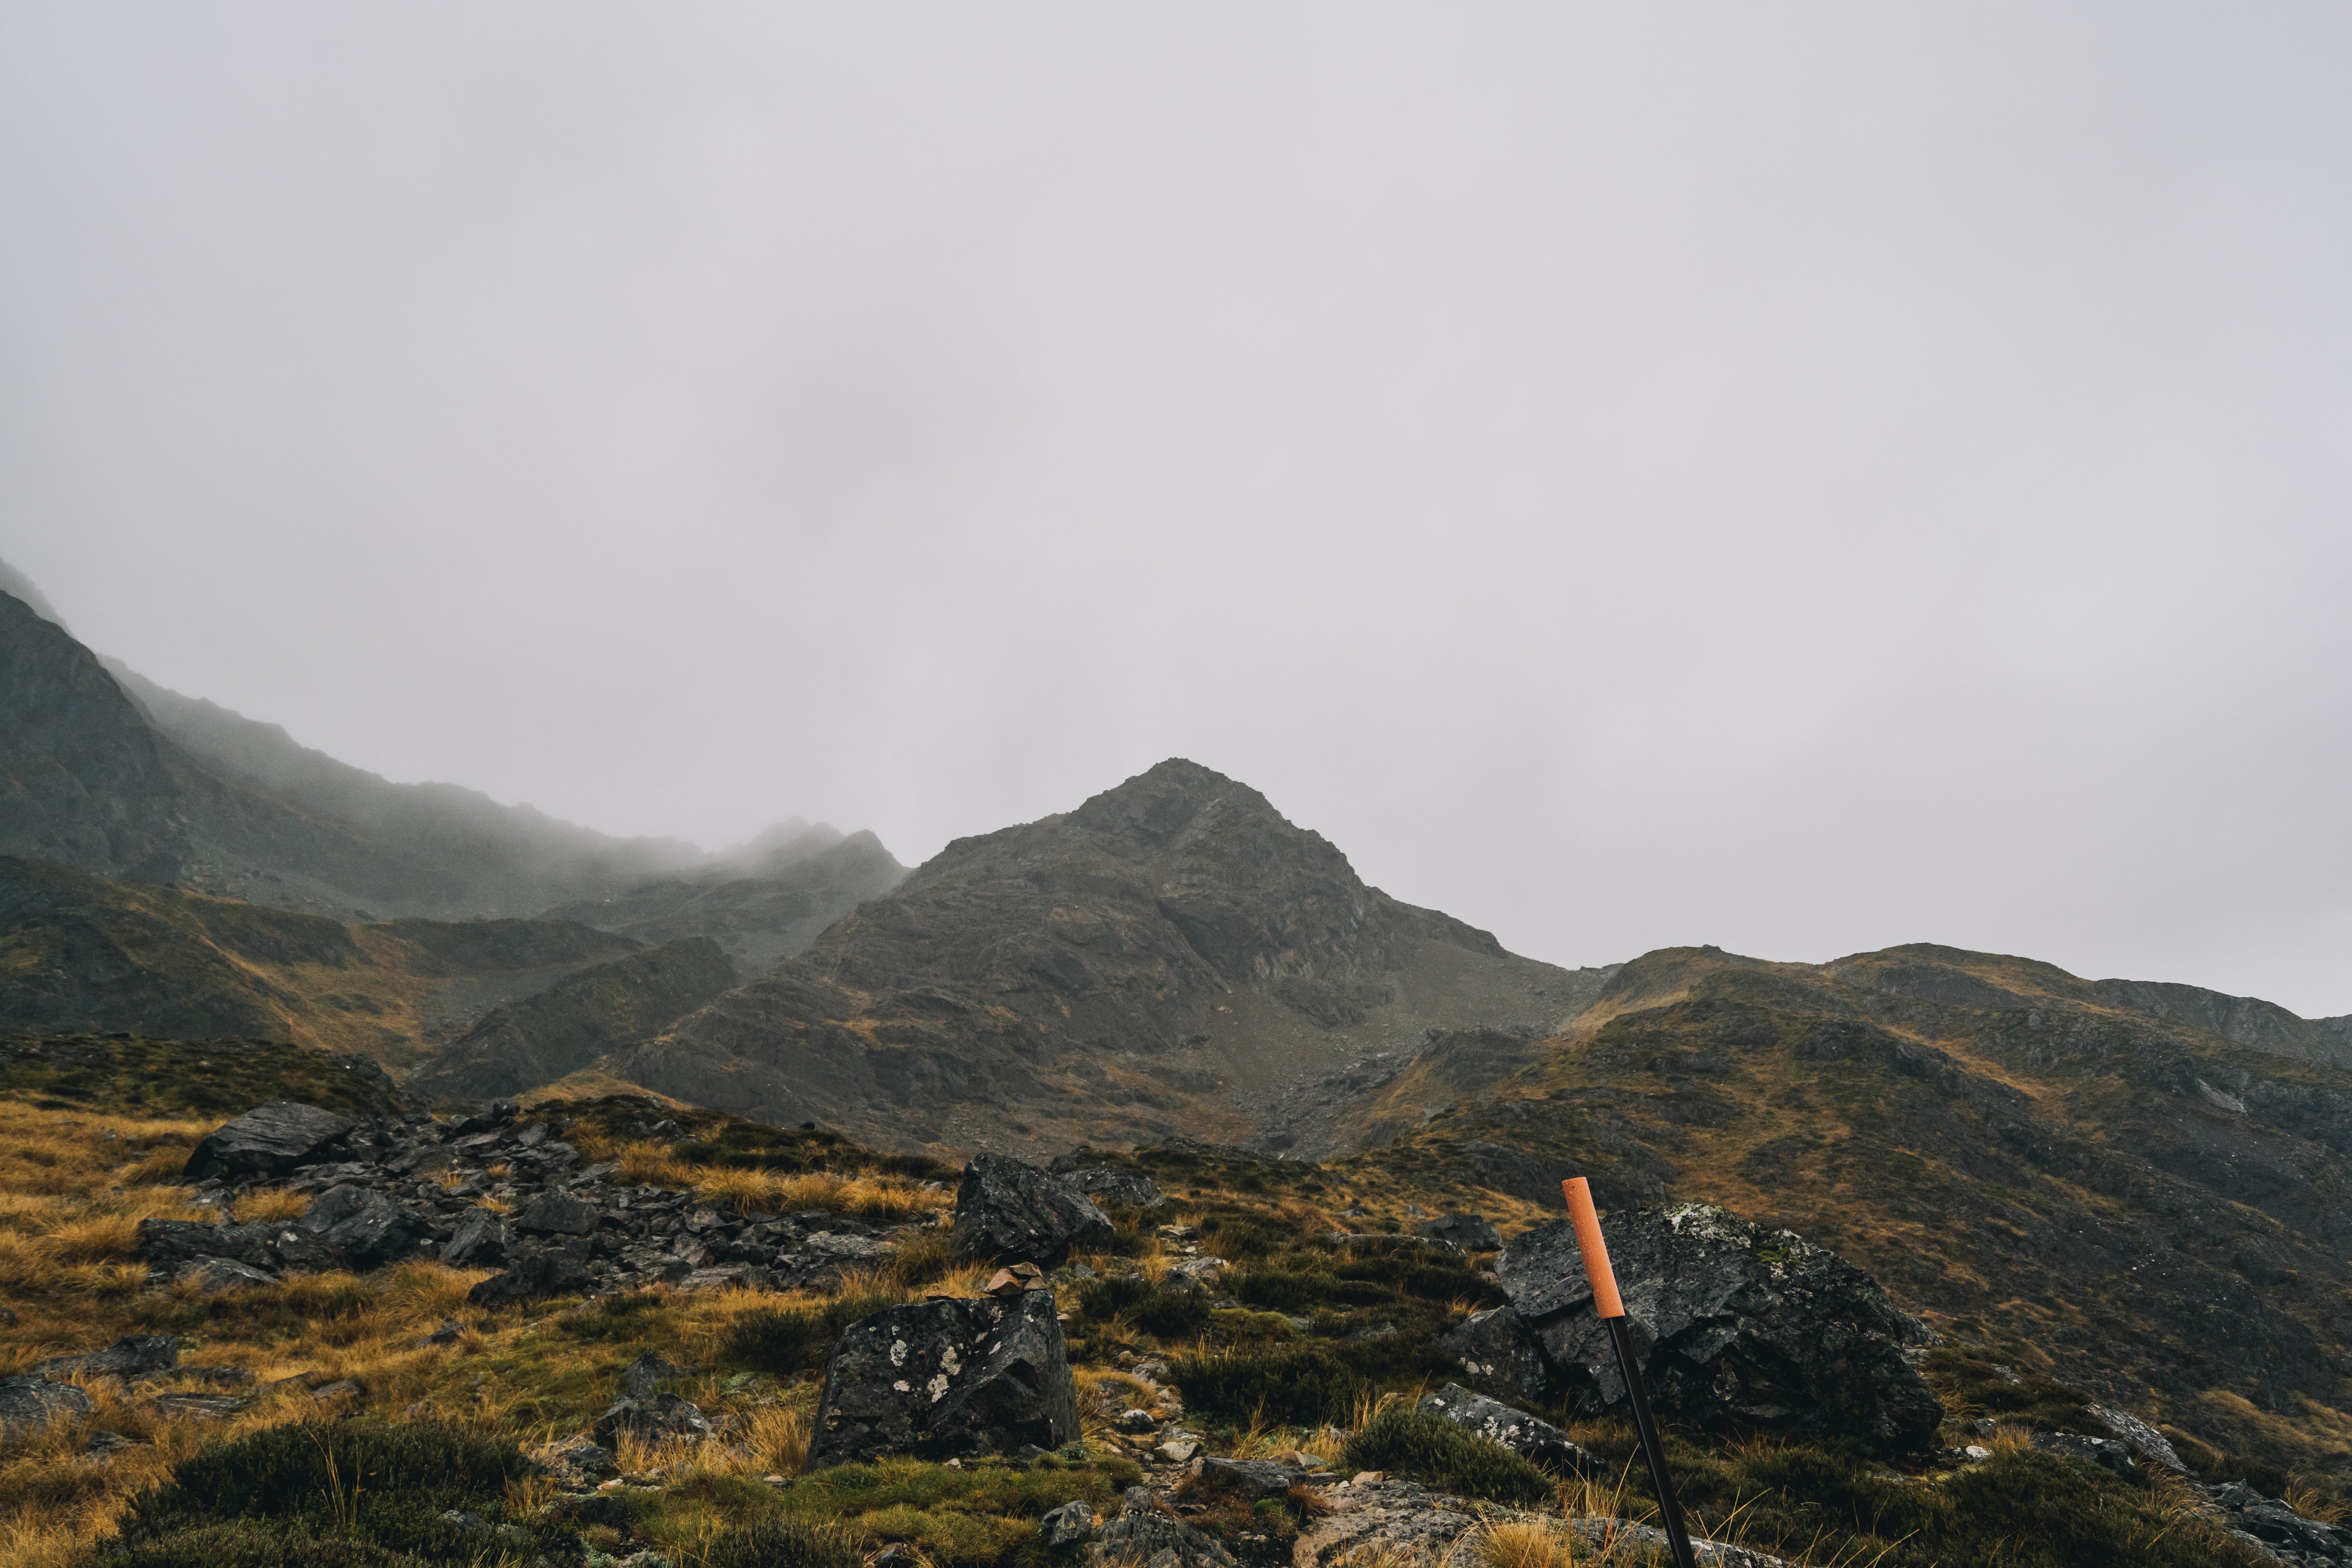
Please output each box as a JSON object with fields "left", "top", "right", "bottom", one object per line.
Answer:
{"left": 1496, "top": 1204, "right": 1943, "bottom": 1453}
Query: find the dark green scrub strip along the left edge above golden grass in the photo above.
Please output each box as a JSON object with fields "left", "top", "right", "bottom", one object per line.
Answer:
{"left": 0, "top": 1034, "right": 407, "bottom": 1121}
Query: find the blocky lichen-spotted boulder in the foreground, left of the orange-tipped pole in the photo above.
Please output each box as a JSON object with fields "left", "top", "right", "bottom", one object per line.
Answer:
{"left": 809, "top": 1291, "right": 1077, "bottom": 1467}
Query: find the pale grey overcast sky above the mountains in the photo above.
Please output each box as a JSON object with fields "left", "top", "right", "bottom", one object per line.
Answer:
{"left": 0, "top": 0, "right": 2352, "bottom": 1013}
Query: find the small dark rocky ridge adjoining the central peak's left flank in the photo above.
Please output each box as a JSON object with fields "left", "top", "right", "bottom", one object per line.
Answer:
{"left": 409, "top": 936, "right": 736, "bottom": 1103}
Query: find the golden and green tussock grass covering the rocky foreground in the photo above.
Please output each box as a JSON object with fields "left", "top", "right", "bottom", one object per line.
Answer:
{"left": 0, "top": 1062, "right": 2326, "bottom": 1568}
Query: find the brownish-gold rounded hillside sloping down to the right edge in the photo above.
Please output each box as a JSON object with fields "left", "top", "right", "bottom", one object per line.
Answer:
{"left": 1341, "top": 945, "right": 2352, "bottom": 1486}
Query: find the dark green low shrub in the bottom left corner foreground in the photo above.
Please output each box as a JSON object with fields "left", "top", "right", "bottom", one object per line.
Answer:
{"left": 99, "top": 1422, "right": 564, "bottom": 1568}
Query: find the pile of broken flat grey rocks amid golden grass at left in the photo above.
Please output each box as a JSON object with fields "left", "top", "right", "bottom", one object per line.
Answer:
{"left": 139, "top": 1100, "right": 917, "bottom": 1307}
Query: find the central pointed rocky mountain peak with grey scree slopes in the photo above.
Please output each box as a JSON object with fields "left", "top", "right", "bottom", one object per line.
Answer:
{"left": 623, "top": 759, "right": 1592, "bottom": 1150}
